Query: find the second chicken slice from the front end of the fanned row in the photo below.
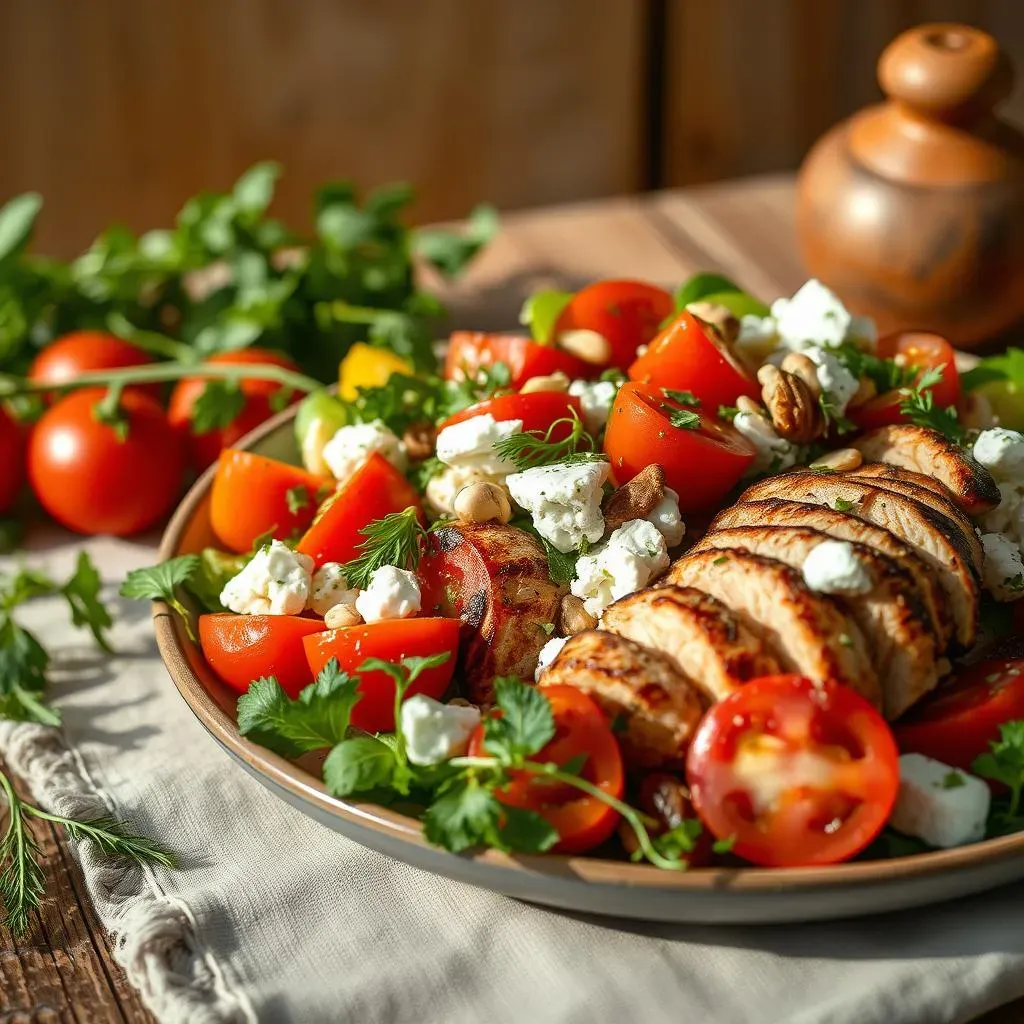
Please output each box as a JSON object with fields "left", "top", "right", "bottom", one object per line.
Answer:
{"left": 601, "top": 587, "right": 779, "bottom": 702}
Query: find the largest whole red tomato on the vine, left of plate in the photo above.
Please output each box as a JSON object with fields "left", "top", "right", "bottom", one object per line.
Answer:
{"left": 29, "top": 388, "right": 185, "bottom": 537}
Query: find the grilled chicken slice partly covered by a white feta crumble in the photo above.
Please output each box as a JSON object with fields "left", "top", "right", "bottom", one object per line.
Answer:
{"left": 692, "top": 526, "right": 939, "bottom": 719}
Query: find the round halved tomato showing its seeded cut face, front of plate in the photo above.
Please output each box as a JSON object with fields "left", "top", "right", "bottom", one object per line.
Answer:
{"left": 686, "top": 676, "right": 899, "bottom": 867}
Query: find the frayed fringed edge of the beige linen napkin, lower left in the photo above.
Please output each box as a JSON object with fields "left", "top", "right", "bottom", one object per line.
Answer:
{"left": 0, "top": 722, "right": 256, "bottom": 1024}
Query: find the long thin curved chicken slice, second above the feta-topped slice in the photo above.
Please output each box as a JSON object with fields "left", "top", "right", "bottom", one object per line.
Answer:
{"left": 740, "top": 473, "right": 978, "bottom": 648}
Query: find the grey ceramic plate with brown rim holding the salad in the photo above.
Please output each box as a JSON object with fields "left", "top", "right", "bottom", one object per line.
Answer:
{"left": 154, "top": 403, "right": 1024, "bottom": 924}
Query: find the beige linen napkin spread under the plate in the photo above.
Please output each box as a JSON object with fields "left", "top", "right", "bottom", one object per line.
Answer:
{"left": 6, "top": 536, "right": 1024, "bottom": 1024}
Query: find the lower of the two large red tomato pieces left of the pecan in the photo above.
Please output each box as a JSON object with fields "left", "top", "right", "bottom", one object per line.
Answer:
{"left": 604, "top": 383, "right": 757, "bottom": 512}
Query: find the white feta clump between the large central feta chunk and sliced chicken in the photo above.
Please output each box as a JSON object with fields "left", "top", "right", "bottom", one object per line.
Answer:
{"left": 569, "top": 519, "right": 670, "bottom": 615}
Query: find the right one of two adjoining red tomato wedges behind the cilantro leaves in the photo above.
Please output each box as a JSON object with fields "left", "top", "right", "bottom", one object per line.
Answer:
{"left": 302, "top": 618, "right": 459, "bottom": 732}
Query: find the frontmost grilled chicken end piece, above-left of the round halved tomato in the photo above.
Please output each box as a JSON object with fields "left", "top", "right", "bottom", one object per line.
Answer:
{"left": 541, "top": 630, "right": 703, "bottom": 768}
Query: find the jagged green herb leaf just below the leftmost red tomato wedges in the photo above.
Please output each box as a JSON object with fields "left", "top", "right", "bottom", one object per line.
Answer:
{"left": 238, "top": 658, "right": 361, "bottom": 758}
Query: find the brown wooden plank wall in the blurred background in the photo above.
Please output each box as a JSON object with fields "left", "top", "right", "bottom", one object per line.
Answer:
{"left": 0, "top": 0, "right": 1024, "bottom": 255}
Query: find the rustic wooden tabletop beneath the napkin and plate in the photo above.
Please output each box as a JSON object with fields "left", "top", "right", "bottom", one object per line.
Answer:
{"left": 0, "top": 176, "right": 1024, "bottom": 1024}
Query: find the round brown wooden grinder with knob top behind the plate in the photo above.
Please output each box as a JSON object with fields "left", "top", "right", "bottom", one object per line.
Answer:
{"left": 797, "top": 25, "right": 1024, "bottom": 346}
